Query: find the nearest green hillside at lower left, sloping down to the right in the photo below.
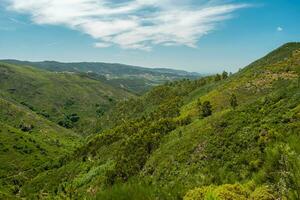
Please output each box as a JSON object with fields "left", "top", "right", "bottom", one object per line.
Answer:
{"left": 0, "top": 98, "right": 81, "bottom": 199}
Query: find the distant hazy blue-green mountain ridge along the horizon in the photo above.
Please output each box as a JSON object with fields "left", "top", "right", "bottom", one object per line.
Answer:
{"left": 2, "top": 60, "right": 201, "bottom": 94}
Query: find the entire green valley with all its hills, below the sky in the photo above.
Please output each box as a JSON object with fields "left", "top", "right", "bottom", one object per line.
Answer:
{"left": 0, "top": 42, "right": 300, "bottom": 200}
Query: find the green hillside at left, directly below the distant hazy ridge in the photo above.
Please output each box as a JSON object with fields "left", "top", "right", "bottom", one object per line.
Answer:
{"left": 0, "top": 63, "right": 134, "bottom": 135}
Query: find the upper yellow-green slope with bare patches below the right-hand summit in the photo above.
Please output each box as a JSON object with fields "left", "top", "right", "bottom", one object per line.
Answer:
{"left": 182, "top": 43, "right": 300, "bottom": 115}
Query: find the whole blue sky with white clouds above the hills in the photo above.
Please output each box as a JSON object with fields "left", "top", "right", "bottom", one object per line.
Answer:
{"left": 0, "top": 0, "right": 300, "bottom": 73}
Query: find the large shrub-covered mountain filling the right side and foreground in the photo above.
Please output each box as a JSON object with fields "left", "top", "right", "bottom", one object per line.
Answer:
{"left": 0, "top": 43, "right": 300, "bottom": 200}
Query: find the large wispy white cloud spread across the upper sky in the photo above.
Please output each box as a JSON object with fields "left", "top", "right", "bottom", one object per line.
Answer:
{"left": 6, "top": 0, "right": 248, "bottom": 50}
